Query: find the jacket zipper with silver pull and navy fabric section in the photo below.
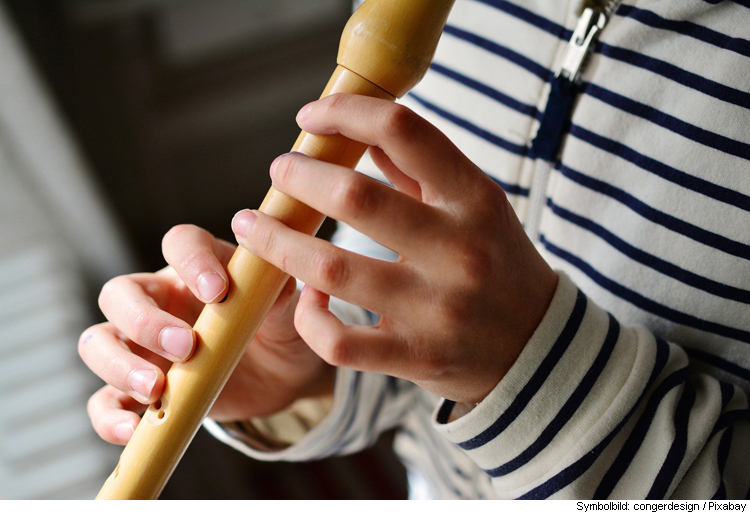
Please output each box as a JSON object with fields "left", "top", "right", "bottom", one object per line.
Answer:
{"left": 525, "top": 0, "right": 622, "bottom": 242}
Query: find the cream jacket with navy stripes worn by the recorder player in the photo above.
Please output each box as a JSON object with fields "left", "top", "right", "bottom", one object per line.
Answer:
{"left": 208, "top": 0, "right": 750, "bottom": 499}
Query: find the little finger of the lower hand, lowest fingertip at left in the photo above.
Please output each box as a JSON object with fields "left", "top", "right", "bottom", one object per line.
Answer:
{"left": 87, "top": 385, "right": 145, "bottom": 445}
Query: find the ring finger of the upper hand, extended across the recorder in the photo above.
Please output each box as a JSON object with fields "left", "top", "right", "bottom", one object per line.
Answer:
{"left": 232, "top": 210, "right": 417, "bottom": 314}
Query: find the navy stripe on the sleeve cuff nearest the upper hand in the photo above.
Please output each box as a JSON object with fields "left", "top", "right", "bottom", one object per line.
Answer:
{"left": 458, "top": 290, "right": 588, "bottom": 450}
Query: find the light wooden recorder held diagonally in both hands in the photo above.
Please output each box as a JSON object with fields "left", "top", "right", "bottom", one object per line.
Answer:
{"left": 97, "top": 0, "right": 454, "bottom": 499}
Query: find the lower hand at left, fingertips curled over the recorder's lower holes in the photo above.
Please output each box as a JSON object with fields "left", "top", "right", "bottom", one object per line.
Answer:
{"left": 78, "top": 225, "right": 333, "bottom": 444}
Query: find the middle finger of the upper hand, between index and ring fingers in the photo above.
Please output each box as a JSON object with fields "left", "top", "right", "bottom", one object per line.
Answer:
{"left": 271, "top": 153, "right": 444, "bottom": 256}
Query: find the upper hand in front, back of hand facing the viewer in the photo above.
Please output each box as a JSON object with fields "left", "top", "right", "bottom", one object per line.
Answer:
{"left": 232, "top": 94, "right": 557, "bottom": 402}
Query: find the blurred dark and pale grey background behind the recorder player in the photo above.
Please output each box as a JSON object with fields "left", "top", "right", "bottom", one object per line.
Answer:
{"left": 0, "top": 0, "right": 406, "bottom": 499}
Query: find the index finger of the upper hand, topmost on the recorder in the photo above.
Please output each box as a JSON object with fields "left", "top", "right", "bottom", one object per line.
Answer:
{"left": 297, "top": 94, "right": 473, "bottom": 198}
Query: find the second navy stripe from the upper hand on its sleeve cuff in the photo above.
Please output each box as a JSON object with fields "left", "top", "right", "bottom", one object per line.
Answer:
{"left": 485, "top": 314, "right": 620, "bottom": 477}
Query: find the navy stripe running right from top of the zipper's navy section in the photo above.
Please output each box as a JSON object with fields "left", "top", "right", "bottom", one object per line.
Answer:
{"left": 583, "top": 84, "right": 750, "bottom": 160}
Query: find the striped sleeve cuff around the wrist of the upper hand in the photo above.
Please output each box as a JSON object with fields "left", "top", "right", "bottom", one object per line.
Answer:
{"left": 433, "top": 273, "right": 637, "bottom": 486}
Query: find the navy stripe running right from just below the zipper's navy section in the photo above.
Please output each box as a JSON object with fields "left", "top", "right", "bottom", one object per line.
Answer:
{"left": 560, "top": 161, "right": 750, "bottom": 260}
